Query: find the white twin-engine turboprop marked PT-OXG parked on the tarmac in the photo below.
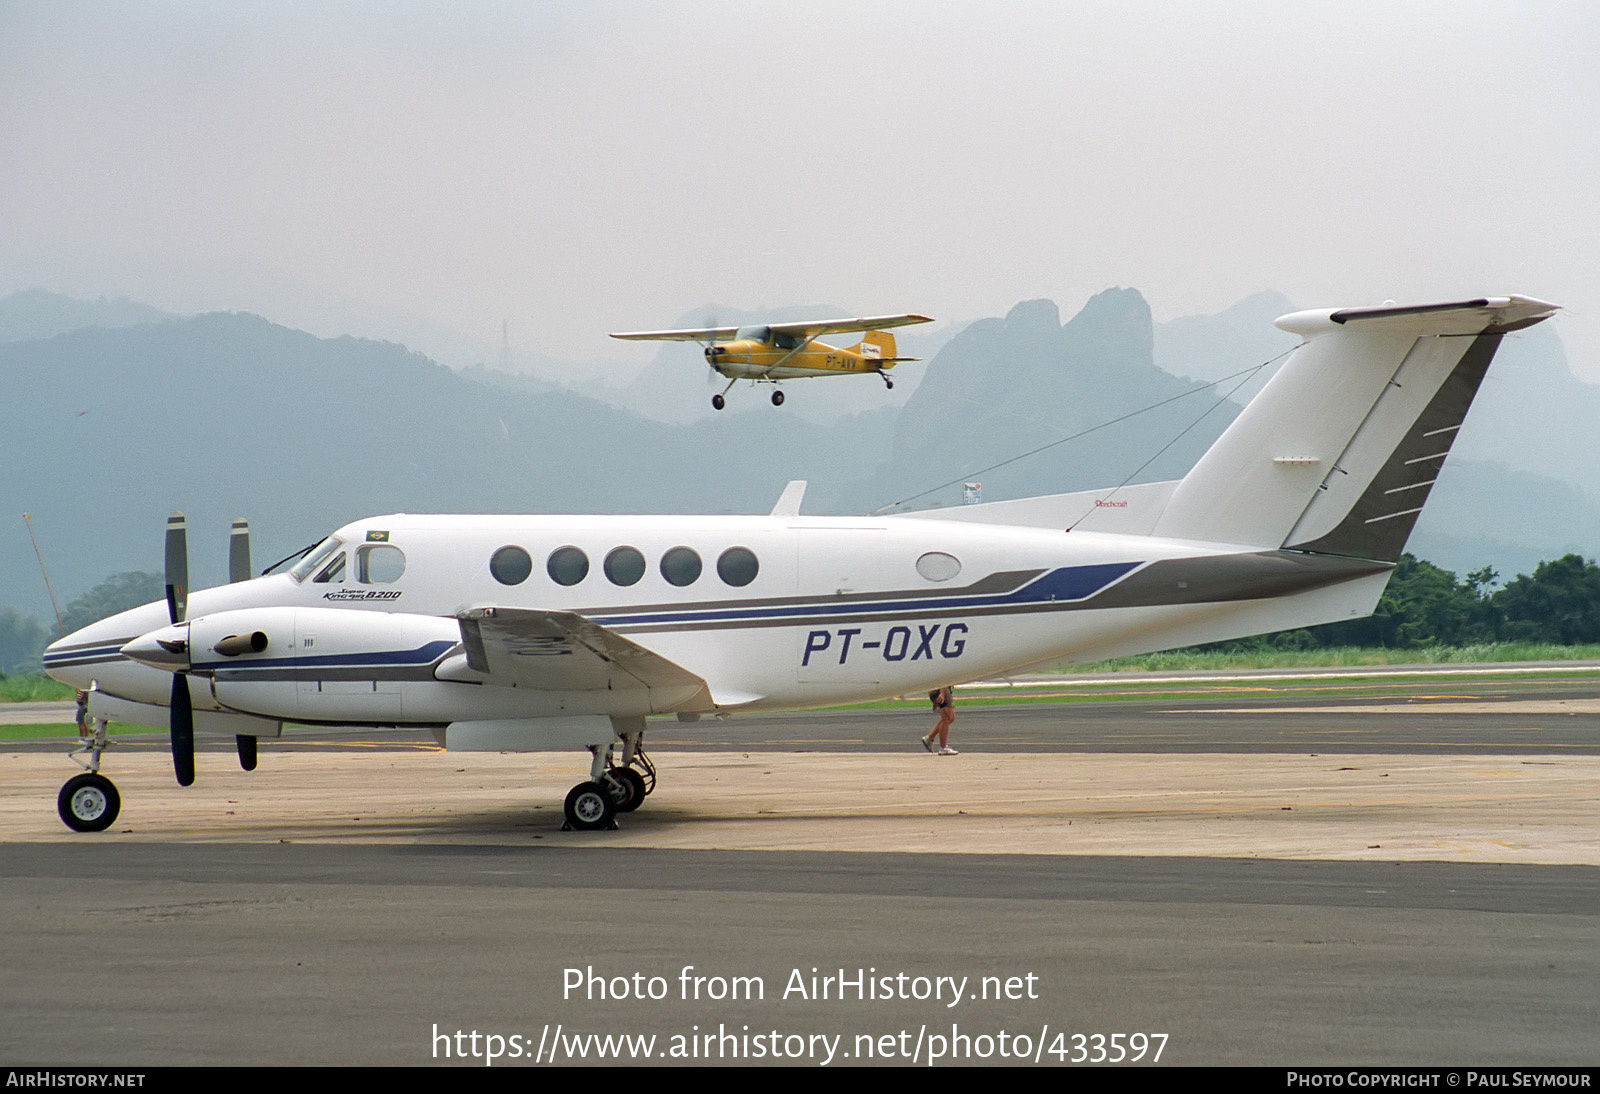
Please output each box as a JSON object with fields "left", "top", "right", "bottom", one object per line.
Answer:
{"left": 45, "top": 296, "right": 1557, "bottom": 830}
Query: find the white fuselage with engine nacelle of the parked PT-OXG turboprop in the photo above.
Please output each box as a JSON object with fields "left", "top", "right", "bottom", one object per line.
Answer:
{"left": 46, "top": 515, "right": 1387, "bottom": 735}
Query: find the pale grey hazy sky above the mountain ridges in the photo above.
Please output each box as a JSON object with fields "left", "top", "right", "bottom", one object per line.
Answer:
{"left": 0, "top": 0, "right": 1600, "bottom": 381}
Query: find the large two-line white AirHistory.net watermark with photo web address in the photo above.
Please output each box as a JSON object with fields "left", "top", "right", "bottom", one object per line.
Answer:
{"left": 430, "top": 964, "right": 1166, "bottom": 1067}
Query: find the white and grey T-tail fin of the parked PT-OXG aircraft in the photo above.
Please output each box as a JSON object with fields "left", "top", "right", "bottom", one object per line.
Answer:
{"left": 1154, "top": 296, "right": 1557, "bottom": 561}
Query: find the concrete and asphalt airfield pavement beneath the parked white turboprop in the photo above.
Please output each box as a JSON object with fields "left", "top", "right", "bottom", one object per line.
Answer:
{"left": 0, "top": 674, "right": 1600, "bottom": 1068}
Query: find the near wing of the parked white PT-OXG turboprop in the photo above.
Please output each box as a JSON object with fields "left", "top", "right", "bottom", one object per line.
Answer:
{"left": 456, "top": 608, "right": 706, "bottom": 691}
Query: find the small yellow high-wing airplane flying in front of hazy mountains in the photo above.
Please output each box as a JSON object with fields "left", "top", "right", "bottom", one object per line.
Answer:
{"left": 611, "top": 315, "right": 933, "bottom": 409}
